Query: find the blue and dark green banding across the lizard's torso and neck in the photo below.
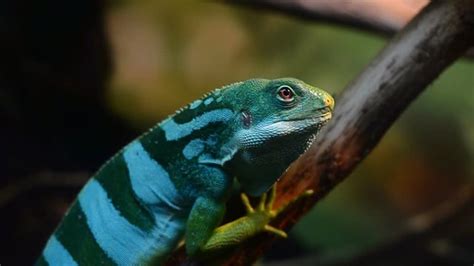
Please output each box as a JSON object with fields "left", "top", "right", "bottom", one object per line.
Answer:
{"left": 38, "top": 105, "right": 234, "bottom": 265}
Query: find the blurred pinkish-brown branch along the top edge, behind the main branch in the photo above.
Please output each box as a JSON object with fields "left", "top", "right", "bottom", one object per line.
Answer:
{"left": 225, "top": 0, "right": 474, "bottom": 58}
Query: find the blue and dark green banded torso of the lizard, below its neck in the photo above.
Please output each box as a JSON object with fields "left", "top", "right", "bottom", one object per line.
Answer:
{"left": 40, "top": 140, "right": 187, "bottom": 265}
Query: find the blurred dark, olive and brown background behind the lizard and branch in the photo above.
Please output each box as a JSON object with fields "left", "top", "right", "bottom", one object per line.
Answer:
{"left": 0, "top": 0, "right": 474, "bottom": 265}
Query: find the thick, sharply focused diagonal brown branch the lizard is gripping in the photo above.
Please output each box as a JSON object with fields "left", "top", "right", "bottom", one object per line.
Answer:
{"left": 167, "top": 0, "right": 474, "bottom": 265}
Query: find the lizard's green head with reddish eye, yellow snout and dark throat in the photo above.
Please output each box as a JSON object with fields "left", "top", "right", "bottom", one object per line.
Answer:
{"left": 224, "top": 78, "right": 334, "bottom": 196}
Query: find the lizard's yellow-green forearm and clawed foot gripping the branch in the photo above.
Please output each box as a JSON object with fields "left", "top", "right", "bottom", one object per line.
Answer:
{"left": 199, "top": 185, "right": 313, "bottom": 256}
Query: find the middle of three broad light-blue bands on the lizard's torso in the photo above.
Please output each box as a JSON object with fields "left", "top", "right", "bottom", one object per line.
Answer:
{"left": 79, "top": 179, "right": 185, "bottom": 265}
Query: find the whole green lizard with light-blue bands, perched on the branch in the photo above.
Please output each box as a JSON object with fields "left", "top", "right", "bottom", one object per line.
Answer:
{"left": 39, "top": 78, "right": 334, "bottom": 265}
